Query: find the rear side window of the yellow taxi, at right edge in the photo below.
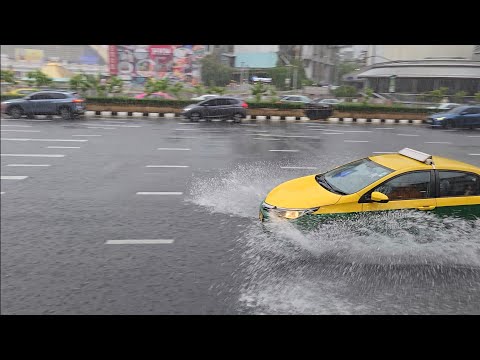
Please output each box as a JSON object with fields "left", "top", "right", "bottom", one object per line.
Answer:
{"left": 438, "top": 171, "right": 480, "bottom": 197}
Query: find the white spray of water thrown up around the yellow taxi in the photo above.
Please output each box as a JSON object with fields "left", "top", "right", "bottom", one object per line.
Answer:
{"left": 188, "top": 160, "right": 480, "bottom": 314}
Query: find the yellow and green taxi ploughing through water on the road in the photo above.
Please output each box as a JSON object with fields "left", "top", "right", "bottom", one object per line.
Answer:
{"left": 259, "top": 148, "right": 480, "bottom": 221}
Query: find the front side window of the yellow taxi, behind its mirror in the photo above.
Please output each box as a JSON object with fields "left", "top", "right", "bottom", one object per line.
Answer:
{"left": 372, "top": 171, "right": 431, "bottom": 201}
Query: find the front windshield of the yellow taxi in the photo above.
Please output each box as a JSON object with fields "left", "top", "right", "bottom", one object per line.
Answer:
{"left": 317, "top": 158, "right": 393, "bottom": 194}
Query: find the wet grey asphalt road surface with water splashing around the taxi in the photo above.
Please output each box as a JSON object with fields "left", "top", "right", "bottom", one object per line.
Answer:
{"left": 1, "top": 118, "right": 480, "bottom": 315}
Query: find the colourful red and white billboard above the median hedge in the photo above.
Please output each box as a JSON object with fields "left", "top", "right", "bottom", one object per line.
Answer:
{"left": 108, "top": 45, "right": 205, "bottom": 84}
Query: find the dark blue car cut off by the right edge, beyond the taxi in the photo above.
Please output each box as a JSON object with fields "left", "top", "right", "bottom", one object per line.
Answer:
{"left": 426, "top": 105, "right": 480, "bottom": 129}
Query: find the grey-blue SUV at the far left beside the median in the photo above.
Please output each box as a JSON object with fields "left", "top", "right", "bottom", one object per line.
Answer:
{"left": 1, "top": 90, "right": 85, "bottom": 120}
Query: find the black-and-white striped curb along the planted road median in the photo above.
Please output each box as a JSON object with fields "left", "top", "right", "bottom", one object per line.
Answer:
{"left": 85, "top": 111, "right": 425, "bottom": 125}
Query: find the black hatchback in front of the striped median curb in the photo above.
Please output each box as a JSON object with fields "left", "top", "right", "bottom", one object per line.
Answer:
{"left": 182, "top": 96, "right": 248, "bottom": 122}
